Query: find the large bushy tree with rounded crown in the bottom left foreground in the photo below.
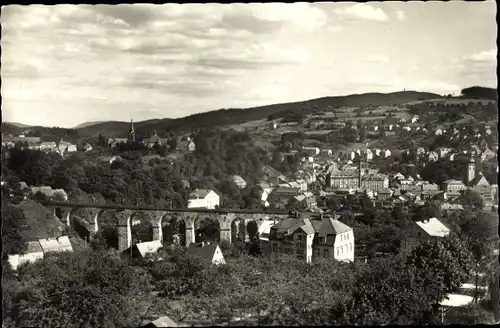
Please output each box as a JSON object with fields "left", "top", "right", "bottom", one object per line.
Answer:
{"left": 8, "top": 252, "right": 149, "bottom": 327}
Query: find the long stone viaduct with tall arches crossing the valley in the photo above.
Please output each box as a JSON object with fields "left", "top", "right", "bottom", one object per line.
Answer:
{"left": 42, "top": 203, "right": 291, "bottom": 251}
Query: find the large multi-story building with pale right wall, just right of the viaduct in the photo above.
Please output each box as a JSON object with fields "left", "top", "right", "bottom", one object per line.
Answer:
{"left": 269, "top": 218, "right": 354, "bottom": 262}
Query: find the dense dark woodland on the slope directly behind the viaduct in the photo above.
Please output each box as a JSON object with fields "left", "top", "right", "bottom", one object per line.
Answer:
{"left": 3, "top": 130, "right": 267, "bottom": 208}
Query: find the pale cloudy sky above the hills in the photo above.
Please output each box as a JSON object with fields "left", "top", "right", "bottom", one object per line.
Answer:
{"left": 0, "top": 1, "right": 497, "bottom": 128}
